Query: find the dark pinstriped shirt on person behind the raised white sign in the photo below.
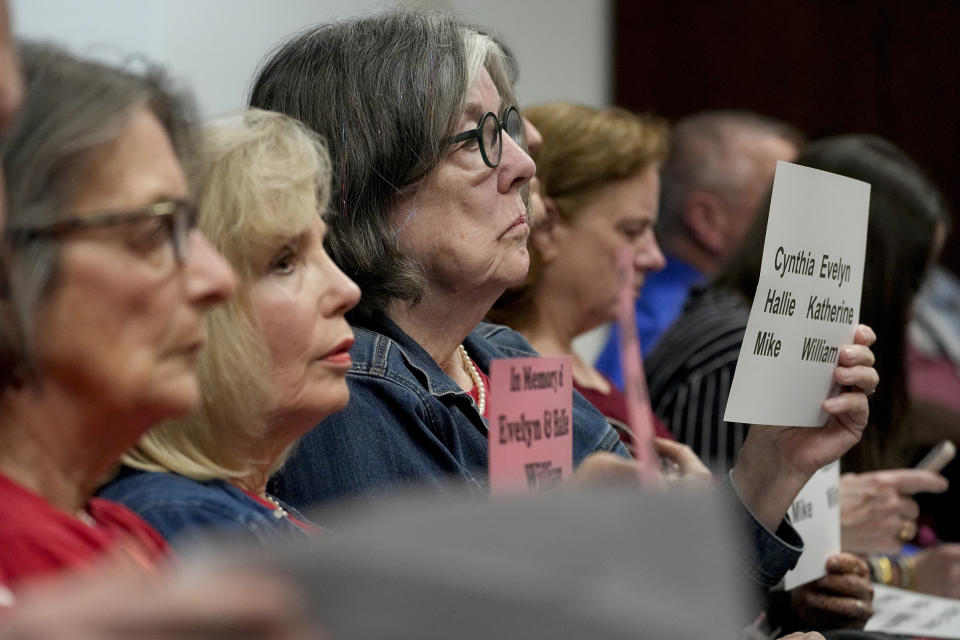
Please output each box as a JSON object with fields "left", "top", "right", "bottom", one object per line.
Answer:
{"left": 644, "top": 288, "right": 750, "bottom": 474}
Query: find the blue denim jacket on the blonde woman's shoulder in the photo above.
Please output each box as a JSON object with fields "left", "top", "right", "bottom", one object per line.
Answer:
{"left": 100, "top": 467, "right": 310, "bottom": 546}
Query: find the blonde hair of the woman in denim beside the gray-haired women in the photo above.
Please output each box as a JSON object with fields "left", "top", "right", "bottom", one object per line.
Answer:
{"left": 123, "top": 109, "right": 330, "bottom": 480}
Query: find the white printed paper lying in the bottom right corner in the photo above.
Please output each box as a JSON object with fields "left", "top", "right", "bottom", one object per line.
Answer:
{"left": 864, "top": 584, "right": 960, "bottom": 638}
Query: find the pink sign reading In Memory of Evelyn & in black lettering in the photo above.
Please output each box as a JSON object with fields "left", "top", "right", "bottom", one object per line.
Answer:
{"left": 488, "top": 356, "right": 573, "bottom": 495}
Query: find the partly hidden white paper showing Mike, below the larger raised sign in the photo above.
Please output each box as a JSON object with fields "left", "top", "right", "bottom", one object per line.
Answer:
{"left": 783, "top": 462, "right": 840, "bottom": 590}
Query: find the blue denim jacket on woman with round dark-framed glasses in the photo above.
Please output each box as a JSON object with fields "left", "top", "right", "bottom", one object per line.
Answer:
{"left": 271, "top": 316, "right": 627, "bottom": 508}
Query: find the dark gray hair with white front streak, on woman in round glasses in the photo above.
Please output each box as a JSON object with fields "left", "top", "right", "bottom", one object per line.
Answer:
{"left": 250, "top": 11, "right": 515, "bottom": 318}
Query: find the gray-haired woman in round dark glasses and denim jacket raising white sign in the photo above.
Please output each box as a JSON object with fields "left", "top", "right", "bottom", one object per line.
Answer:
{"left": 251, "top": 11, "right": 877, "bottom": 600}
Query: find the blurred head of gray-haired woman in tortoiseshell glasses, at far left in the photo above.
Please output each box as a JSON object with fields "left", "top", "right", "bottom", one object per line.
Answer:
{"left": 0, "top": 44, "right": 232, "bottom": 428}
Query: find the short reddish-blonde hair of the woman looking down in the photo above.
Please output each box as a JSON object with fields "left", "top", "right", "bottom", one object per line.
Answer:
{"left": 488, "top": 102, "right": 669, "bottom": 328}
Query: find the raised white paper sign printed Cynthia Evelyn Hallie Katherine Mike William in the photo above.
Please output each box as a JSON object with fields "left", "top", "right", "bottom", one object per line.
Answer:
{"left": 723, "top": 162, "right": 872, "bottom": 427}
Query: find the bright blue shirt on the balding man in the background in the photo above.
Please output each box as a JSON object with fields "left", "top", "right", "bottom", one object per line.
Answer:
{"left": 596, "top": 255, "right": 704, "bottom": 389}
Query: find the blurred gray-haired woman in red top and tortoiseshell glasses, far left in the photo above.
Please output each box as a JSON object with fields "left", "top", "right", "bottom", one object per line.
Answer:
{"left": 0, "top": 46, "right": 233, "bottom": 588}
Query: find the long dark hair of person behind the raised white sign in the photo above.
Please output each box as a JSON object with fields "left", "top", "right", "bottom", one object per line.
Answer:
{"left": 714, "top": 135, "right": 950, "bottom": 472}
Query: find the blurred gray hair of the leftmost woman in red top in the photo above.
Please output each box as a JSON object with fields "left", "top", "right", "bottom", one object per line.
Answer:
{"left": 0, "top": 43, "right": 193, "bottom": 391}
